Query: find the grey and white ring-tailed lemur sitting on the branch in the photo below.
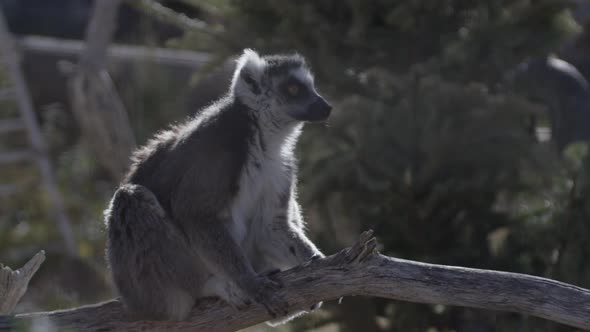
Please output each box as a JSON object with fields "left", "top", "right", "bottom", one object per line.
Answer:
{"left": 105, "top": 49, "right": 332, "bottom": 320}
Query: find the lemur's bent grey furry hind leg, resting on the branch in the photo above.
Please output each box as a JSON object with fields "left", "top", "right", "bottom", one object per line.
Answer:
{"left": 105, "top": 185, "right": 202, "bottom": 319}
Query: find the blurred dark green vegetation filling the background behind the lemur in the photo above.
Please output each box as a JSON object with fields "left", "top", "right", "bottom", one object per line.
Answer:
{"left": 0, "top": 0, "right": 590, "bottom": 332}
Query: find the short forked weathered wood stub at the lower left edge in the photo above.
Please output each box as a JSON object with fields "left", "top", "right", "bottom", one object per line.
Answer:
{"left": 0, "top": 251, "right": 45, "bottom": 315}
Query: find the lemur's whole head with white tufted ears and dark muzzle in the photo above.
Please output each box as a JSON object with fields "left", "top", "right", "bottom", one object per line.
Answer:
{"left": 231, "top": 49, "right": 332, "bottom": 121}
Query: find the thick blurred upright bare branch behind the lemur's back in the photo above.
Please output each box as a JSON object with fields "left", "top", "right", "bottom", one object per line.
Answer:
{"left": 68, "top": 0, "right": 135, "bottom": 181}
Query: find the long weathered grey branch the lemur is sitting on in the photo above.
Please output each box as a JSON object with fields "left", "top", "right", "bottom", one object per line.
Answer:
{"left": 4, "top": 232, "right": 590, "bottom": 332}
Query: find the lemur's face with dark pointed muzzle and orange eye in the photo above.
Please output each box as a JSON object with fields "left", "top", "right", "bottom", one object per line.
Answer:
{"left": 271, "top": 67, "right": 332, "bottom": 121}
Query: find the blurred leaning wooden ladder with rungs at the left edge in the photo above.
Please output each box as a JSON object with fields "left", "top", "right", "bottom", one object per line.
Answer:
{"left": 0, "top": 10, "right": 77, "bottom": 256}
